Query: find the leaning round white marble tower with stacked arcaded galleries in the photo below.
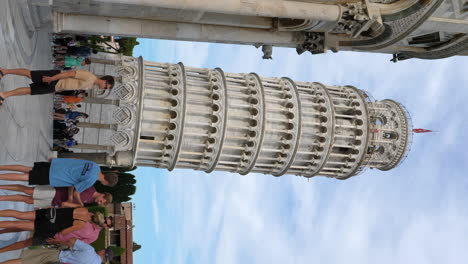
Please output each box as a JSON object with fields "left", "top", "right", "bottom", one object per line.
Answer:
{"left": 63, "top": 57, "right": 411, "bottom": 179}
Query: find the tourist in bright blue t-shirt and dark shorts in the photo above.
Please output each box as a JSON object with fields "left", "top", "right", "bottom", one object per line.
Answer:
{"left": 0, "top": 158, "right": 118, "bottom": 194}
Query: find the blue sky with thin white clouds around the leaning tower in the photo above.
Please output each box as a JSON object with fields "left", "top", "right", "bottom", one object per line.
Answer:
{"left": 133, "top": 39, "right": 468, "bottom": 264}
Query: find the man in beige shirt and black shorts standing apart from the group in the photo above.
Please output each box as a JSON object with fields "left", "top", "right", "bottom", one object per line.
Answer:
{"left": 0, "top": 69, "right": 114, "bottom": 105}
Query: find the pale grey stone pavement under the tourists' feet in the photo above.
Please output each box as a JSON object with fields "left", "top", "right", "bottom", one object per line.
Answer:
{"left": 0, "top": 0, "right": 52, "bottom": 261}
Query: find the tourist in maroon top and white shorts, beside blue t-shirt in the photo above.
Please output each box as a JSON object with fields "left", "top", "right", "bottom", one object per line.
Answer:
{"left": 0, "top": 184, "right": 112, "bottom": 209}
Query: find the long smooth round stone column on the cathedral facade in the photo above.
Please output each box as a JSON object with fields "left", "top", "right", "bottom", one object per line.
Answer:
{"left": 54, "top": 13, "right": 304, "bottom": 47}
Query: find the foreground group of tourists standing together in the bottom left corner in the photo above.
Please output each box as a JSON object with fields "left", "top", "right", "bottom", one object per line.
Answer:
{"left": 0, "top": 158, "right": 118, "bottom": 264}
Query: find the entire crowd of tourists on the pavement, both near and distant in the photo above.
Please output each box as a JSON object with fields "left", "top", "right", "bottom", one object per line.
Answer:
{"left": 0, "top": 36, "right": 118, "bottom": 264}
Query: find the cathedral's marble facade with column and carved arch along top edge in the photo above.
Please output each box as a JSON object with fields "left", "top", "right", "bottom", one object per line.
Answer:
{"left": 29, "top": 0, "right": 468, "bottom": 61}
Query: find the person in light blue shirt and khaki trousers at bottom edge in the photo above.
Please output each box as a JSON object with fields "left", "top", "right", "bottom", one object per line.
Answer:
{"left": 0, "top": 238, "right": 114, "bottom": 264}
